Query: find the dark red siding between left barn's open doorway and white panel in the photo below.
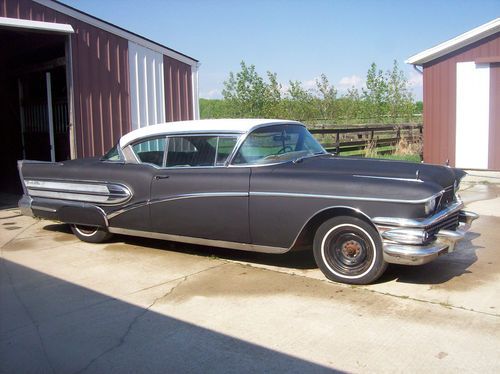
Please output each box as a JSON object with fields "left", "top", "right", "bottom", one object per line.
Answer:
{"left": 0, "top": 0, "right": 131, "bottom": 157}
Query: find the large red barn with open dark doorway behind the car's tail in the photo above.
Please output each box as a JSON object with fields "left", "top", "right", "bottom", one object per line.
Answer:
{"left": 0, "top": 0, "right": 199, "bottom": 191}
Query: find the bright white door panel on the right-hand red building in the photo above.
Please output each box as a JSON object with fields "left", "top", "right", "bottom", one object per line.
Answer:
{"left": 455, "top": 62, "right": 490, "bottom": 169}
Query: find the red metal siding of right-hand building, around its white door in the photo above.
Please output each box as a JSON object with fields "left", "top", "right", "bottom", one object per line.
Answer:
{"left": 424, "top": 33, "right": 500, "bottom": 166}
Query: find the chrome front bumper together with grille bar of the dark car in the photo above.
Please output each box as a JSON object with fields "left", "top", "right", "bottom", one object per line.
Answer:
{"left": 374, "top": 201, "right": 479, "bottom": 265}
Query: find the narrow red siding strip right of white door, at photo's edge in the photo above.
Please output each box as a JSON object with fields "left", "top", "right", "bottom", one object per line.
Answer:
{"left": 488, "top": 63, "right": 500, "bottom": 170}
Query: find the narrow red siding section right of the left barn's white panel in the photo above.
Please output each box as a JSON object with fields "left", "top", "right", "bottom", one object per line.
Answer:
{"left": 163, "top": 55, "right": 193, "bottom": 122}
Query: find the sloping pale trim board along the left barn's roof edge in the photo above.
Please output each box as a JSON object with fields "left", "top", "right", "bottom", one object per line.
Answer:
{"left": 33, "top": 0, "right": 197, "bottom": 66}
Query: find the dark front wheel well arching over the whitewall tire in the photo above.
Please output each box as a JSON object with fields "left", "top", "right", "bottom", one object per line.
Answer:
{"left": 291, "top": 207, "right": 375, "bottom": 250}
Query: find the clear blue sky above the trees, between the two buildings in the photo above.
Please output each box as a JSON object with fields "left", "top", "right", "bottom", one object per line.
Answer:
{"left": 62, "top": 0, "right": 500, "bottom": 100}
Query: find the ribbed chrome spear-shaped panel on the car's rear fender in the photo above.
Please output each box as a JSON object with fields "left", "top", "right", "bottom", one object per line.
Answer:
{"left": 25, "top": 179, "right": 132, "bottom": 205}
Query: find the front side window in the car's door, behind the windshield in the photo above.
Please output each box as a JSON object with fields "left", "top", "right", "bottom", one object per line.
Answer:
{"left": 165, "top": 135, "right": 237, "bottom": 167}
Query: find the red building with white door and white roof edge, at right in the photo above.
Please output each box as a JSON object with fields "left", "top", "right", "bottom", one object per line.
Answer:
{"left": 406, "top": 18, "right": 500, "bottom": 170}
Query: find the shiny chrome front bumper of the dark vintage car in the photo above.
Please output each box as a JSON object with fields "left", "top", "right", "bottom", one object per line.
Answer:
{"left": 377, "top": 204, "right": 479, "bottom": 265}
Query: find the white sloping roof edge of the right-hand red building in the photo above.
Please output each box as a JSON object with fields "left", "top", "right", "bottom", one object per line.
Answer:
{"left": 405, "top": 18, "right": 500, "bottom": 65}
